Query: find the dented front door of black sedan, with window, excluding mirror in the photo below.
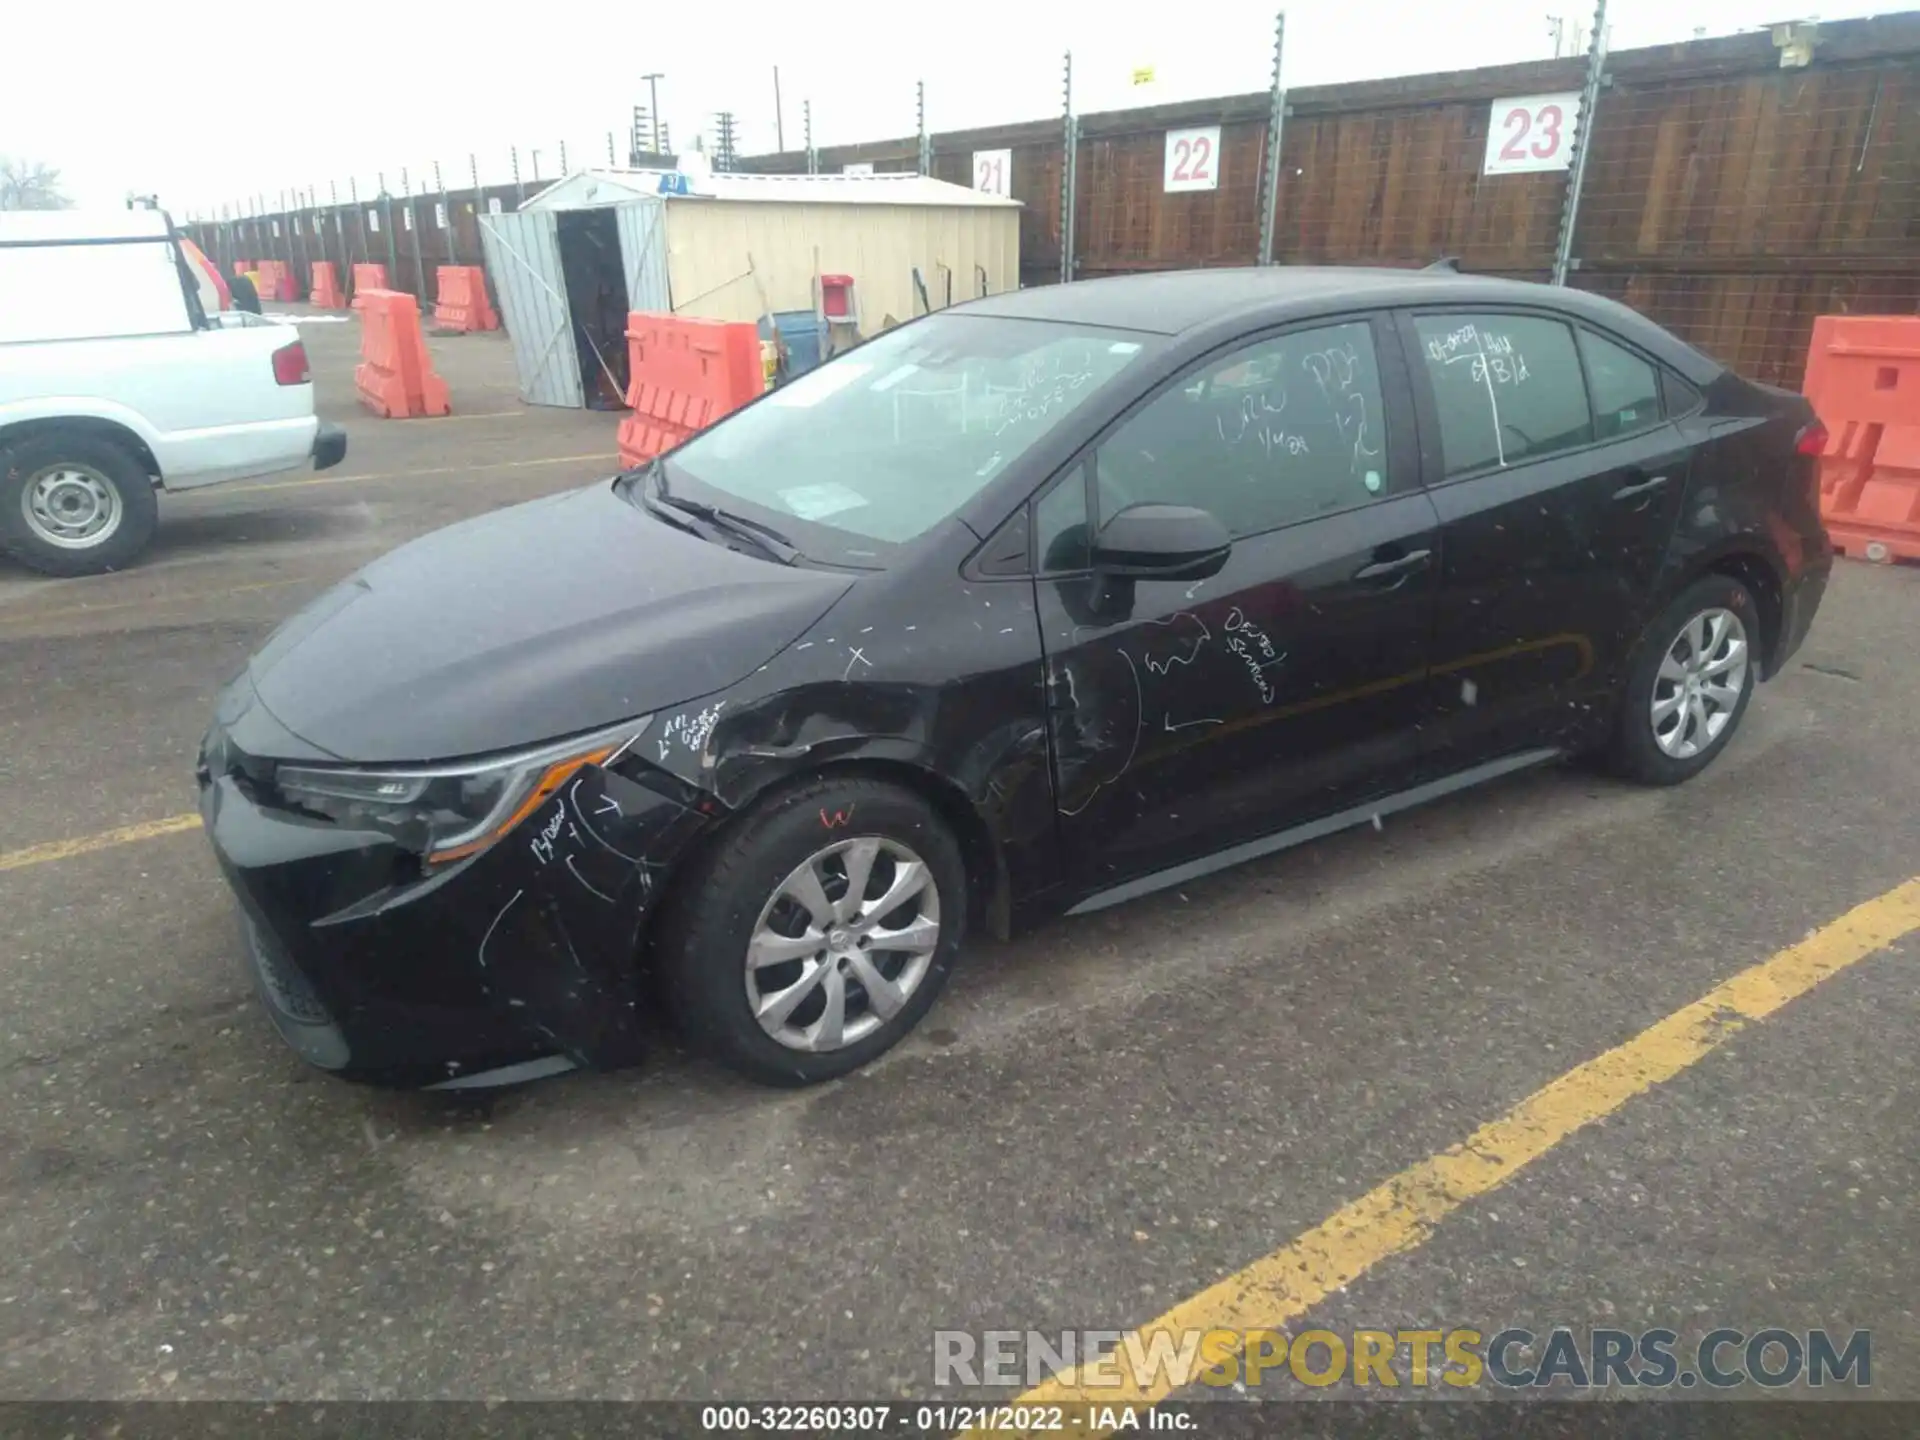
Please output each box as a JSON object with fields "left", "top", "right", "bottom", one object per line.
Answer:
{"left": 1035, "top": 317, "right": 1440, "bottom": 889}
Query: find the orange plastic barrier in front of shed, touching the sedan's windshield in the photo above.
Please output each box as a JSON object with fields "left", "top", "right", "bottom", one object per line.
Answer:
{"left": 620, "top": 311, "right": 766, "bottom": 468}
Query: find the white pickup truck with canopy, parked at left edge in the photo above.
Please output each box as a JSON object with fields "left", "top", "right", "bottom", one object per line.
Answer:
{"left": 0, "top": 209, "right": 348, "bottom": 576}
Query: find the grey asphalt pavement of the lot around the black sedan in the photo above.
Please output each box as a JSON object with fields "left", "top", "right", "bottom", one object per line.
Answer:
{"left": 0, "top": 311, "right": 1920, "bottom": 1400}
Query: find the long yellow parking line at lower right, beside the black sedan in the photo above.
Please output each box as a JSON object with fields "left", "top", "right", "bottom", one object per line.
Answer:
{"left": 1016, "top": 877, "right": 1920, "bottom": 1434}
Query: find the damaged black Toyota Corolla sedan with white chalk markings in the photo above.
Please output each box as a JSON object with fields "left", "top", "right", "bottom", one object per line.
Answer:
{"left": 200, "top": 269, "right": 1832, "bottom": 1085}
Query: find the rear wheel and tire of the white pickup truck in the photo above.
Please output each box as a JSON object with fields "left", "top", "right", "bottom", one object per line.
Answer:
{"left": 0, "top": 430, "right": 159, "bottom": 576}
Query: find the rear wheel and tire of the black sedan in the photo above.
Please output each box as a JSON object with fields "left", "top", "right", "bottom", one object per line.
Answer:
{"left": 1607, "top": 574, "right": 1761, "bottom": 785}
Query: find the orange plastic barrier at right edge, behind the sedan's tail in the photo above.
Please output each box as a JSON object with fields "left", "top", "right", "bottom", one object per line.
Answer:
{"left": 1805, "top": 315, "right": 1920, "bottom": 563}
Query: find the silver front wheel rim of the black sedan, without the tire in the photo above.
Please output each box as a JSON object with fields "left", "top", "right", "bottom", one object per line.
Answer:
{"left": 747, "top": 835, "right": 941, "bottom": 1052}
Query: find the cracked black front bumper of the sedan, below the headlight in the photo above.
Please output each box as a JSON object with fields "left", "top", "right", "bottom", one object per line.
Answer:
{"left": 200, "top": 680, "right": 708, "bottom": 1085}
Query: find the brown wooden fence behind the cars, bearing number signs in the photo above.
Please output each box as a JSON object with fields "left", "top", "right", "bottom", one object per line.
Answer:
{"left": 196, "top": 12, "right": 1920, "bottom": 386}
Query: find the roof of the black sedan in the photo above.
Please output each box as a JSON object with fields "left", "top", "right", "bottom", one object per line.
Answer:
{"left": 964, "top": 265, "right": 1724, "bottom": 384}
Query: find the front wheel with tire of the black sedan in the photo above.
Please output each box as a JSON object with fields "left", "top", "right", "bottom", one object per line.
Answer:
{"left": 659, "top": 776, "right": 968, "bottom": 1085}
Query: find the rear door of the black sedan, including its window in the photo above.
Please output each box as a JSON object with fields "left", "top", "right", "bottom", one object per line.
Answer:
{"left": 1402, "top": 309, "right": 1690, "bottom": 770}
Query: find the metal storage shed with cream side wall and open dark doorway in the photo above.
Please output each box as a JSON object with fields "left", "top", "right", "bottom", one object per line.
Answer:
{"left": 484, "top": 171, "right": 1020, "bottom": 414}
